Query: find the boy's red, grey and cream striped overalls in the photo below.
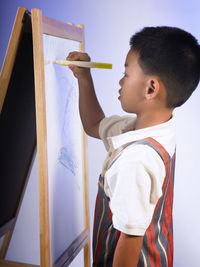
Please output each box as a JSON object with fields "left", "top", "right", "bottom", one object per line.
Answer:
{"left": 93, "top": 138, "right": 175, "bottom": 267}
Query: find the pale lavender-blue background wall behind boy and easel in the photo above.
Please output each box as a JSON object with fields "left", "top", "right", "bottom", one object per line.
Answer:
{"left": 0, "top": 0, "right": 200, "bottom": 267}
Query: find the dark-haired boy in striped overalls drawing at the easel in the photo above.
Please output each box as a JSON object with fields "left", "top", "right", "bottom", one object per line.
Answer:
{"left": 67, "top": 27, "right": 200, "bottom": 267}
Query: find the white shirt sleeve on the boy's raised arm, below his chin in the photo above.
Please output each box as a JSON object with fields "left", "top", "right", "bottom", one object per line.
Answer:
{"left": 99, "top": 115, "right": 136, "bottom": 151}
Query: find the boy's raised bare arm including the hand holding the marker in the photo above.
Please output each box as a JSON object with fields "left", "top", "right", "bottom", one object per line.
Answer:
{"left": 67, "top": 52, "right": 105, "bottom": 138}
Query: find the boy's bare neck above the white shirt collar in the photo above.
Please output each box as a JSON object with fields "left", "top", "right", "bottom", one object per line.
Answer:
{"left": 135, "top": 109, "right": 173, "bottom": 130}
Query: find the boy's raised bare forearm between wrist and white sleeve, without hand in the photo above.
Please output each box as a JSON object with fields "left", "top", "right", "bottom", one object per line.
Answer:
{"left": 78, "top": 73, "right": 105, "bottom": 138}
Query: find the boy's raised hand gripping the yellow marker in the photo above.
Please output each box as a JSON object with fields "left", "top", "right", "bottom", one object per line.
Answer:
{"left": 66, "top": 51, "right": 90, "bottom": 79}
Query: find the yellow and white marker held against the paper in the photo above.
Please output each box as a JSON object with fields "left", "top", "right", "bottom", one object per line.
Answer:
{"left": 54, "top": 59, "right": 112, "bottom": 69}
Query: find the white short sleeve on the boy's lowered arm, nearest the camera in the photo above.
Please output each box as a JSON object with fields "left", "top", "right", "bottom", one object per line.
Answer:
{"left": 106, "top": 145, "right": 165, "bottom": 235}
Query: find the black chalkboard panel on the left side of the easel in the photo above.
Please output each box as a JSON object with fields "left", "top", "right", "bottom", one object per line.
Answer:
{"left": 0, "top": 32, "right": 36, "bottom": 231}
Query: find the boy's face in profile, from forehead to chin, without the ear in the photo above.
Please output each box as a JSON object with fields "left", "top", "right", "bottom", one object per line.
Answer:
{"left": 119, "top": 49, "right": 148, "bottom": 114}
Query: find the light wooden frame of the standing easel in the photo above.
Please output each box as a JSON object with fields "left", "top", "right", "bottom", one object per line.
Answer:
{"left": 0, "top": 7, "right": 90, "bottom": 267}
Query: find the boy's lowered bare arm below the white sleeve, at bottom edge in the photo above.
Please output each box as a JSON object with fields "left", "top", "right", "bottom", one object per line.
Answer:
{"left": 113, "top": 233, "right": 143, "bottom": 267}
